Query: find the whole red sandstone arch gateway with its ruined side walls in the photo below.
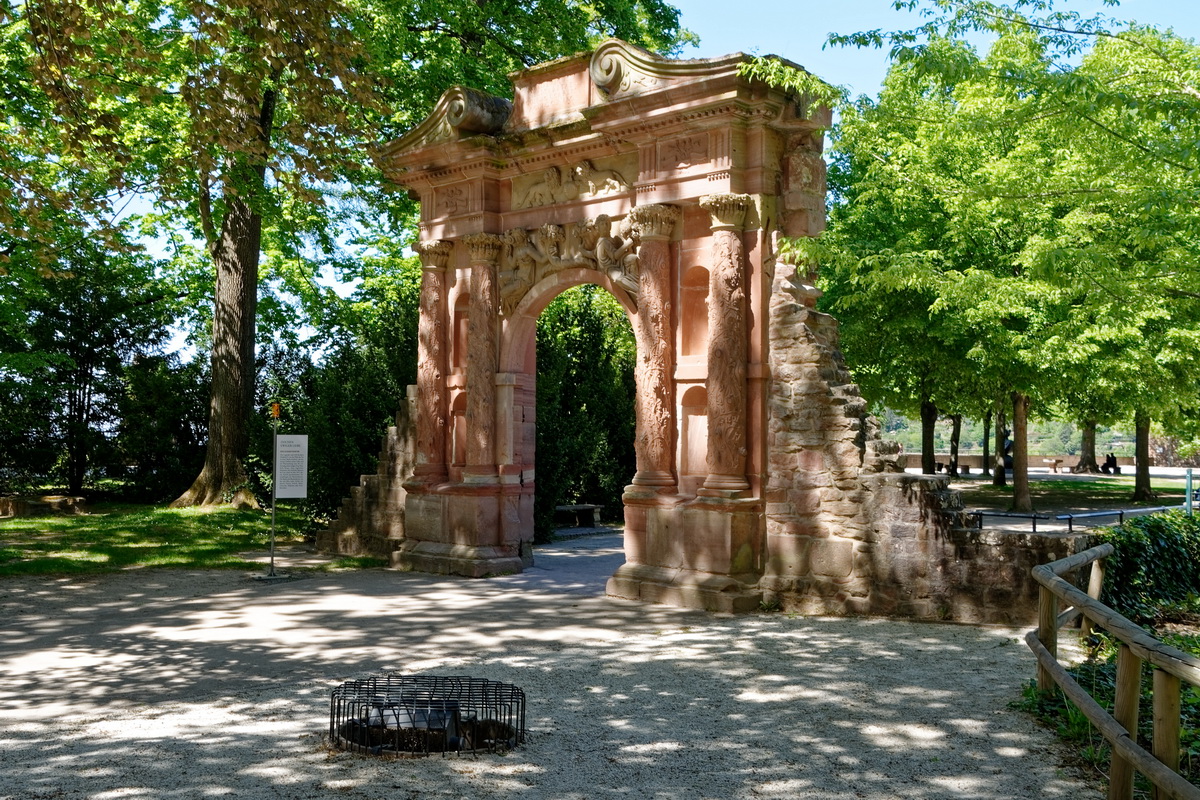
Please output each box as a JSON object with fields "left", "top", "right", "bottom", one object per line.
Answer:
{"left": 320, "top": 40, "right": 1080, "bottom": 620}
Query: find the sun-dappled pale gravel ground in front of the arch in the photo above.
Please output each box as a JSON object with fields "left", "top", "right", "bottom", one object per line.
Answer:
{"left": 0, "top": 535, "right": 1100, "bottom": 800}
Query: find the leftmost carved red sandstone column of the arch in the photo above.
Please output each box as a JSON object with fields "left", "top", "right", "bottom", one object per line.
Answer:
{"left": 413, "top": 241, "right": 454, "bottom": 483}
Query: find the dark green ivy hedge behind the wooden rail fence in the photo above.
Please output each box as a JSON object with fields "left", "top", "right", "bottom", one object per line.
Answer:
{"left": 1098, "top": 511, "right": 1200, "bottom": 620}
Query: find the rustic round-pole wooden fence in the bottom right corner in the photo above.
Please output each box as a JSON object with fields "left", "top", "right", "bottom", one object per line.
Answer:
{"left": 1025, "top": 545, "right": 1200, "bottom": 800}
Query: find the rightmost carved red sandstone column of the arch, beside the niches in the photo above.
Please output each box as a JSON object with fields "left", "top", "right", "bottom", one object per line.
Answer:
{"left": 700, "top": 194, "right": 752, "bottom": 495}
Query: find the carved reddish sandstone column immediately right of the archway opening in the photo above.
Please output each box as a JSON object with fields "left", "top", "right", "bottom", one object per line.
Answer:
{"left": 629, "top": 205, "right": 679, "bottom": 488}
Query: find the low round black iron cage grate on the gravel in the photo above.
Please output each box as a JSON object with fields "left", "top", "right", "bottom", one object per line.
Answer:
{"left": 329, "top": 675, "right": 526, "bottom": 756}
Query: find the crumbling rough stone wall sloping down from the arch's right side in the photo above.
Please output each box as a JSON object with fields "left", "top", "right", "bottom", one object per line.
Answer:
{"left": 760, "top": 277, "right": 1088, "bottom": 624}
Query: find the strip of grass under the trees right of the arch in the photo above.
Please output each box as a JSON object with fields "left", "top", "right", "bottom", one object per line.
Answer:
{"left": 962, "top": 475, "right": 1183, "bottom": 509}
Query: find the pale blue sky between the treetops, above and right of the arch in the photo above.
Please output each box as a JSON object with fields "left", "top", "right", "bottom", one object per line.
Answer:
{"left": 671, "top": 0, "right": 1200, "bottom": 95}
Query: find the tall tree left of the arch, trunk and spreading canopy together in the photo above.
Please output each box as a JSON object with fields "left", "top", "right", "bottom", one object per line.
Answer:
{"left": 14, "top": 0, "right": 685, "bottom": 505}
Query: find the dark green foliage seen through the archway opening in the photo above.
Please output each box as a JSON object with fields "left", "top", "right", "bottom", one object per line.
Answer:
{"left": 534, "top": 285, "right": 636, "bottom": 542}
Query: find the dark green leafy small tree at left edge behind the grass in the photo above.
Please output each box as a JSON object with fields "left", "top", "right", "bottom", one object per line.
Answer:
{"left": 0, "top": 226, "right": 175, "bottom": 493}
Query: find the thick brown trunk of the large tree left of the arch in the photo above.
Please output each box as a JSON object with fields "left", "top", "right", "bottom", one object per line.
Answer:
{"left": 170, "top": 198, "right": 262, "bottom": 507}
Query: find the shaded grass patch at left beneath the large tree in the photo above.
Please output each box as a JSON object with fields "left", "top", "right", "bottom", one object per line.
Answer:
{"left": 0, "top": 504, "right": 306, "bottom": 576}
